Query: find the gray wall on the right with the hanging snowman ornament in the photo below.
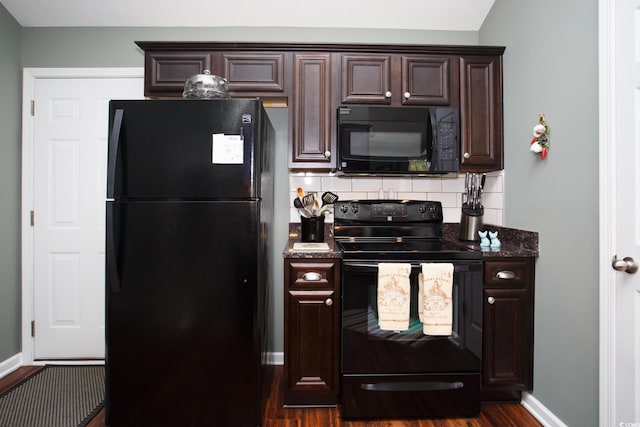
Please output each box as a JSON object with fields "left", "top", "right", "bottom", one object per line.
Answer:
{"left": 479, "top": 0, "right": 599, "bottom": 426}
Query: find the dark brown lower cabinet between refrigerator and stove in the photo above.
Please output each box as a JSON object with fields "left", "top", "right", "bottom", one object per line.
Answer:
{"left": 284, "top": 259, "right": 340, "bottom": 406}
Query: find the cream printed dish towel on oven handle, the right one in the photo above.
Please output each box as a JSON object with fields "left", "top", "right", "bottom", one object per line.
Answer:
{"left": 422, "top": 263, "right": 453, "bottom": 335}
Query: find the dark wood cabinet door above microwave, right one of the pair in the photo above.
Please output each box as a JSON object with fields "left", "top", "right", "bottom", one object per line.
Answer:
{"left": 402, "top": 56, "right": 451, "bottom": 105}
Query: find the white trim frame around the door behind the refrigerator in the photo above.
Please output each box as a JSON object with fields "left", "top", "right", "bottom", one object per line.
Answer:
{"left": 20, "top": 67, "right": 144, "bottom": 365}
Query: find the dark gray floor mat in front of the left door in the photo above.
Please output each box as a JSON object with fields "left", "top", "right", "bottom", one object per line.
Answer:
{"left": 0, "top": 366, "right": 104, "bottom": 427}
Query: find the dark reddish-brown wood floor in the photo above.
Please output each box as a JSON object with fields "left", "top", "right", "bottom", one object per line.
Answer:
{"left": 0, "top": 366, "right": 542, "bottom": 427}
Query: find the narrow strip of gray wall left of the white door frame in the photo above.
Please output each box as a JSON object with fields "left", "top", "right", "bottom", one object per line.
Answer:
{"left": 0, "top": 4, "right": 22, "bottom": 362}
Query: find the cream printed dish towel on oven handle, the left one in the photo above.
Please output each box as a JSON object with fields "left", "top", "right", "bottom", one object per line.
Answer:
{"left": 378, "top": 263, "right": 411, "bottom": 331}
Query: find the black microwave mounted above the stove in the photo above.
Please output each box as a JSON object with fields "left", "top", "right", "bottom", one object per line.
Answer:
{"left": 337, "top": 106, "right": 460, "bottom": 175}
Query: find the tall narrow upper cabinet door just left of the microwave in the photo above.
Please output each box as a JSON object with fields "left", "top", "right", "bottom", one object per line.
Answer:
{"left": 289, "top": 53, "right": 335, "bottom": 169}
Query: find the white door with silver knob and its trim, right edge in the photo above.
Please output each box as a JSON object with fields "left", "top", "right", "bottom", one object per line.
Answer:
{"left": 600, "top": 0, "right": 640, "bottom": 426}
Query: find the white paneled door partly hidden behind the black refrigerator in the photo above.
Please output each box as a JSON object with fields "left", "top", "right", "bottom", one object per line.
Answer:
{"left": 32, "top": 72, "right": 143, "bottom": 360}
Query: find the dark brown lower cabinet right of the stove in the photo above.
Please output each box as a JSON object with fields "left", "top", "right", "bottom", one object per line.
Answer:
{"left": 482, "top": 258, "right": 535, "bottom": 401}
